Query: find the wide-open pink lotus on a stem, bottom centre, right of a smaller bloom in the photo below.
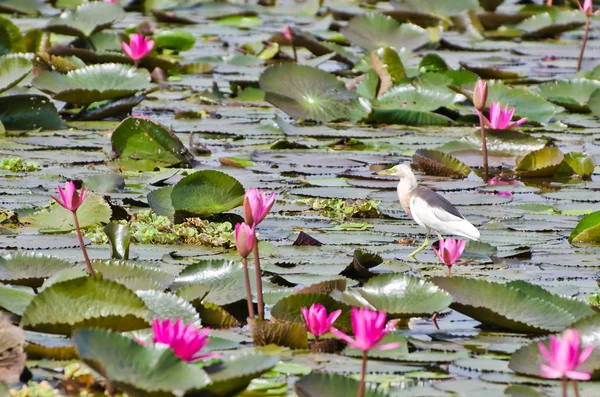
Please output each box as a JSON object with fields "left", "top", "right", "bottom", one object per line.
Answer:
{"left": 331, "top": 307, "right": 401, "bottom": 352}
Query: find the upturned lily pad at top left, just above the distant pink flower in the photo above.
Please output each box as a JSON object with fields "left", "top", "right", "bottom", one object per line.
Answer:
{"left": 46, "top": 1, "right": 125, "bottom": 38}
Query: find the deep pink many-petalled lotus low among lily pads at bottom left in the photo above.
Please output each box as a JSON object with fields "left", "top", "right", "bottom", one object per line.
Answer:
{"left": 152, "top": 317, "right": 219, "bottom": 362}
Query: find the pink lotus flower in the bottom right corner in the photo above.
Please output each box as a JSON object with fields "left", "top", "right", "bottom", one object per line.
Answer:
{"left": 538, "top": 329, "right": 594, "bottom": 380}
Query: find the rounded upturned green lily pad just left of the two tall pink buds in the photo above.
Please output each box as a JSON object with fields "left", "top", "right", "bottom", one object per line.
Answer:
{"left": 171, "top": 170, "right": 246, "bottom": 218}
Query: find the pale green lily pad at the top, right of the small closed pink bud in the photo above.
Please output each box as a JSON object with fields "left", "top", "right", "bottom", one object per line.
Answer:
{"left": 341, "top": 13, "right": 429, "bottom": 51}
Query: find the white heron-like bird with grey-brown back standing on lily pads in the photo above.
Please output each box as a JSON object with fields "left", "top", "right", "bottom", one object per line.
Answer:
{"left": 378, "top": 164, "right": 480, "bottom": 260}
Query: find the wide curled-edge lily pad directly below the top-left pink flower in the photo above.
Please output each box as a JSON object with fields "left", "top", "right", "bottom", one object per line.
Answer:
{"left": 32, "top": 62, "right": 150, "bottom": 105}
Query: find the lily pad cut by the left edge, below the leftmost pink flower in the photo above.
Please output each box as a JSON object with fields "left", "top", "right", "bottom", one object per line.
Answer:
{"left": 0, "top": 252, "right": 73, "bottom": 288}
